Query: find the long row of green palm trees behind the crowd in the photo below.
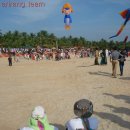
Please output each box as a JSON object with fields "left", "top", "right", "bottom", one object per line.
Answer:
{"left": 0, "top": 30, "right": 130, "bottom": 49}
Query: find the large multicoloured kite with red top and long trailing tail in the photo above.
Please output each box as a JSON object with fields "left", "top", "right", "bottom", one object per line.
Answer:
{"left": 110, "top": 9, "right": 130, "bottom": 38}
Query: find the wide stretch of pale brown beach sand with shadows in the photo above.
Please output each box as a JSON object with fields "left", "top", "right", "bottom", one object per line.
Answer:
{"left": 0, "top": 58, "right": 130, "bottom": 130}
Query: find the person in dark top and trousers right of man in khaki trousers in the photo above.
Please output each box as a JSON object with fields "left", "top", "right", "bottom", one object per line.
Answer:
{"left": 119, "top": 50, "right": 126, "bottom": 76}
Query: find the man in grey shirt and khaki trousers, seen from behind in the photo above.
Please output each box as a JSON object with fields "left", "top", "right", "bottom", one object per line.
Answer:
{"left": 110, "top": 47, "right": 121, "bottom": 78}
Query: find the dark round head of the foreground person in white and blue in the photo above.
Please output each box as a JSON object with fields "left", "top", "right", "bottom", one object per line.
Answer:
{"left": 74, "top": 99, "right": 93, "bottom": 118}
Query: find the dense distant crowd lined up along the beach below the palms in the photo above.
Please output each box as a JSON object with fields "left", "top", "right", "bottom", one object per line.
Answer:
{"left": 0, "top": 47, "right": 110, "bottom": 61}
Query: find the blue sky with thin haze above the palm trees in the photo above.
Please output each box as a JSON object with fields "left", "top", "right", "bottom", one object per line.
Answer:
{"left": 0, "top": 0, "right": 130, "bottom": 41}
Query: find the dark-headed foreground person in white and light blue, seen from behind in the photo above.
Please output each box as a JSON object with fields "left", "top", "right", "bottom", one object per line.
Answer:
{"left": 65, "top": 99, "right": 99, "bottom": 130}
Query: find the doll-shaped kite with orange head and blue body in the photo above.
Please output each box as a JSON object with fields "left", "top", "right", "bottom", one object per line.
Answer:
{"left": 62, "top": 3, "right": 73, "bottom": 30}
